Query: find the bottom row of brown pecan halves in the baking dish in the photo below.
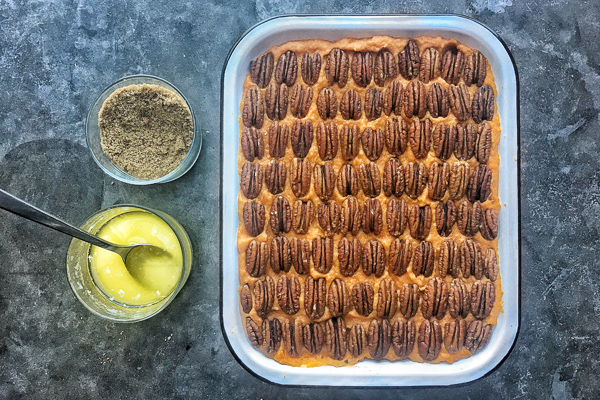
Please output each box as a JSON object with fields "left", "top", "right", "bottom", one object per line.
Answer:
{"left": 246, "top": 317, "right": 493, "bottom": 361}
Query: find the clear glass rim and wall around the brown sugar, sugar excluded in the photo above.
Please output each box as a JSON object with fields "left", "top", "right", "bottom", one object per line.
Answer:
{"left": 85, "top": 75, "right": 202, "bottom": 185}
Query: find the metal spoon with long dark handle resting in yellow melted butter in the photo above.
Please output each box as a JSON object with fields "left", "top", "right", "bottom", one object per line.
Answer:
{"left": 0, "top": 189, "right": 163, "bottom": 262}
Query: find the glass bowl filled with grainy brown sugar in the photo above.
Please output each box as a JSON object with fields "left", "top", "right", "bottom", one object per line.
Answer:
{"left": 86, "top": 75, "right": 202, "bottom": 185}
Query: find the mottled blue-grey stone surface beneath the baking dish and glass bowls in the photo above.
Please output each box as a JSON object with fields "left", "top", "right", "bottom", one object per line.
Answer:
{"left": 0, "top": 0, "right": 600, "bottom": 399}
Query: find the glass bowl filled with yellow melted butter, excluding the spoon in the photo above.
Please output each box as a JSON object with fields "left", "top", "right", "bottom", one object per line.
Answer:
{"left": 67, "top": 205, "right": 192, "bottom": 322}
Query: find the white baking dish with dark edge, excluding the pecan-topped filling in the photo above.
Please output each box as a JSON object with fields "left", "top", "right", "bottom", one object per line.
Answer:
{"left": 221, "top": 15, "right": 520, "bottom": 386}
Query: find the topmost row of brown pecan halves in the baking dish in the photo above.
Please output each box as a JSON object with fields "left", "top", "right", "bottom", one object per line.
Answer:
{"left": 249, "top": 39, "right": 487, "bottom": 88}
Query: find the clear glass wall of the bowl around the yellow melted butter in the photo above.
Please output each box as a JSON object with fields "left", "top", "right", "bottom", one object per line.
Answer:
{"left": 67, "top": 204, "right": 192, "bottom": 322}
